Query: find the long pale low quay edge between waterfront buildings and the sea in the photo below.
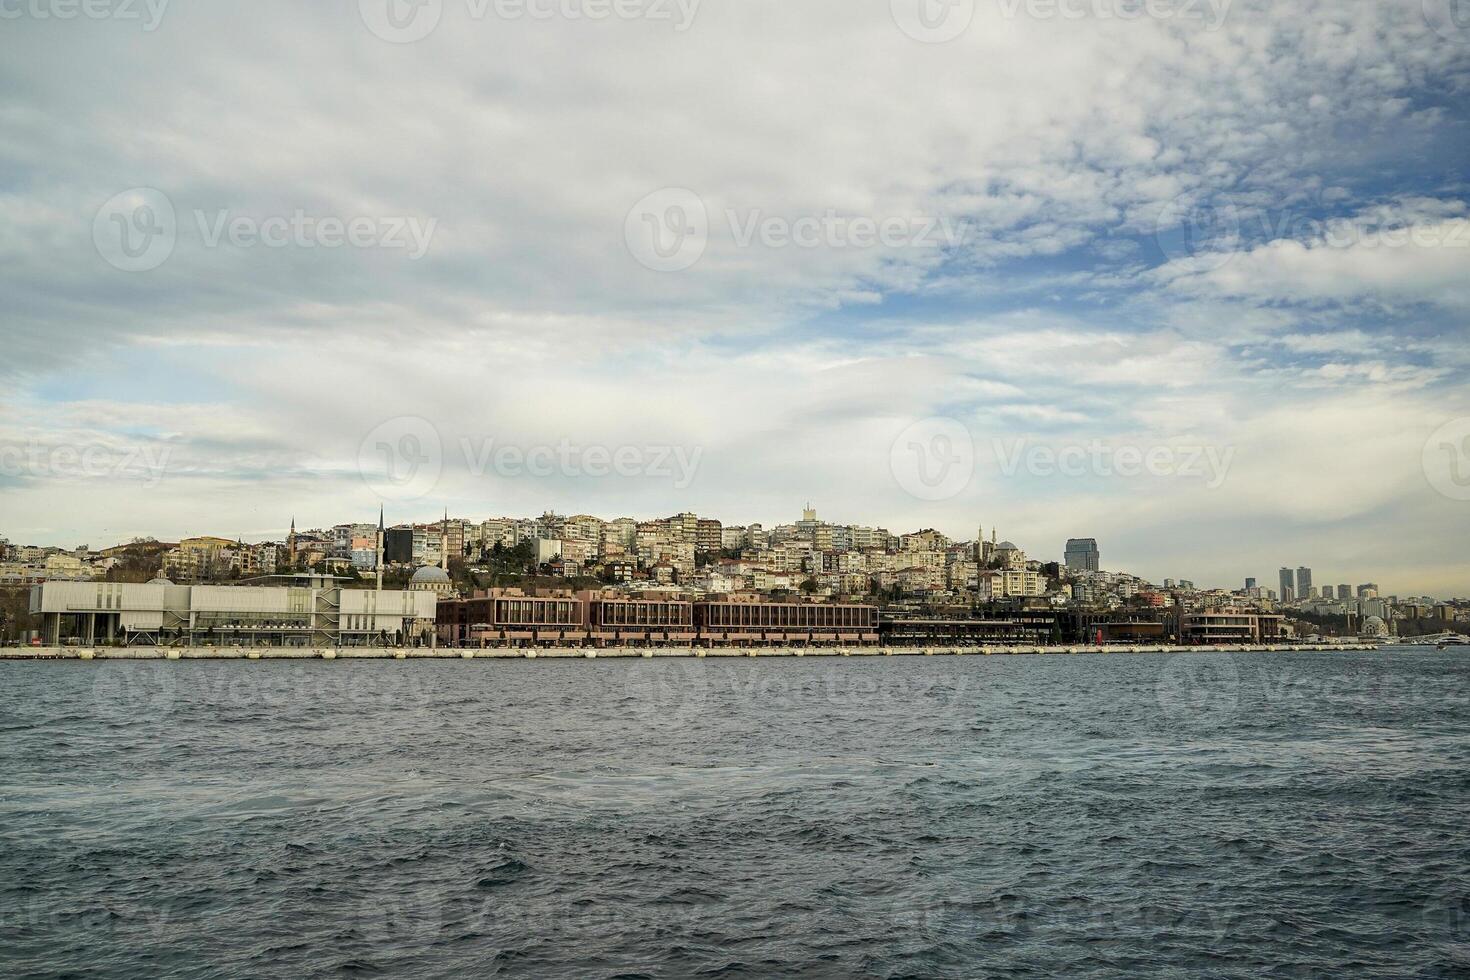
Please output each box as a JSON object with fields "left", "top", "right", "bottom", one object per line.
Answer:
{"left": 0, "top": 642, "right": 1379, "bottom": 663}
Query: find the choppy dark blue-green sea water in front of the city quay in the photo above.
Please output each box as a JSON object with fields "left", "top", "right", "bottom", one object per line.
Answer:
{"left": 0, "top": 651, "right": 1470, "bottom": 979}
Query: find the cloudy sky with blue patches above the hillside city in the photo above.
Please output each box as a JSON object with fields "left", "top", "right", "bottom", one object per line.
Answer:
{"left": 0, "top": 0, "right": 1470, "bottom": 597}
